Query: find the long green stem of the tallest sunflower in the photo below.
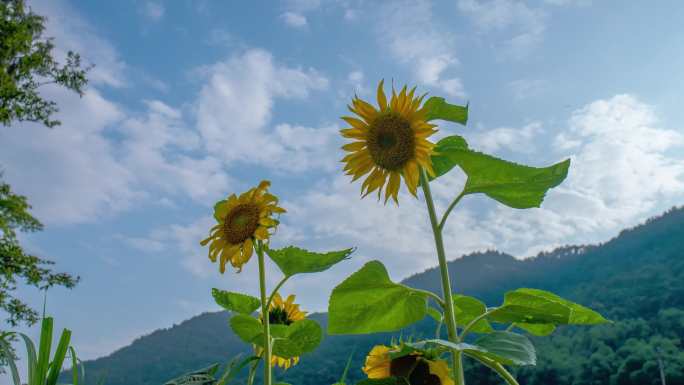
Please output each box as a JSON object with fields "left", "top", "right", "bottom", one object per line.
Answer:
{"left": 420, "top": 167, "right": 465, "bottom": 385}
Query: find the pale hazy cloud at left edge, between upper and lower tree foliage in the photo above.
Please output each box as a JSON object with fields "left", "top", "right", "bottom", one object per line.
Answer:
{"left": 0, "top": 88, "right": 138, "bottom": 224}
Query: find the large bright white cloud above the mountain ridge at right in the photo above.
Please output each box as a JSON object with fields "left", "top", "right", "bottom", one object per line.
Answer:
{"left": 487, "top": 95, "right": 684, "bottom": 255}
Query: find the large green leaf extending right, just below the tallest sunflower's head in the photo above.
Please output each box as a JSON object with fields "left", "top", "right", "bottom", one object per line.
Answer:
{"left": 432, "top": 135, "right": 570, "bottom": 209}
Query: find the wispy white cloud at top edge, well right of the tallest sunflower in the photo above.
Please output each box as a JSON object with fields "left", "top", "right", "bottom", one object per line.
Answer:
{"left": 458, "top": 0, "right": 547, "bottom": 59}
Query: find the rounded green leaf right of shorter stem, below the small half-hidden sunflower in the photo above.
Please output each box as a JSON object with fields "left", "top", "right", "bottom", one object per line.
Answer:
{"left": 273, "top": 319, "right": 323, "bottom": 358}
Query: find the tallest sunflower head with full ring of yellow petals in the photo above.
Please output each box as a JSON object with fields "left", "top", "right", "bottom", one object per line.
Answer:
{"left": 340, "top": 81, "right": 437, "bottom": 204}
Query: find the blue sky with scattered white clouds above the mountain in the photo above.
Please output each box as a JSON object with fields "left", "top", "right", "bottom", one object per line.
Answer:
{"left": 0, "top": 0, "right": 684, "bottom": 366}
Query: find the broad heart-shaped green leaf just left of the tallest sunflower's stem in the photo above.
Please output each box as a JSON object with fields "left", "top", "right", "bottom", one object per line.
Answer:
{"left": 328, "top": 261, "right": 427, "bottom": 334}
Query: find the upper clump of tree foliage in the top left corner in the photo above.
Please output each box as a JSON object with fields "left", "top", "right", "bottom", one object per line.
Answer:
{"left": 0, "top": 0, "right": 87, "bottom": 127}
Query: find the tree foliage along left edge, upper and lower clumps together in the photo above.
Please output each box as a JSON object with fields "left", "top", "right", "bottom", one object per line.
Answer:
{"left": 0, "top": 0, "right": 88, "bottom": 372}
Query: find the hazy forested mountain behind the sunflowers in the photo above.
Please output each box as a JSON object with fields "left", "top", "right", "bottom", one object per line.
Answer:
{"left": 64, "top": 208, "right": 684, "bottom": 385}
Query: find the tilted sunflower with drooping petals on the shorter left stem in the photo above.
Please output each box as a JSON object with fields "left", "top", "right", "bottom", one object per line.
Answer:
{"left": 200, "top": 180, "right": 285, "bottom": 274}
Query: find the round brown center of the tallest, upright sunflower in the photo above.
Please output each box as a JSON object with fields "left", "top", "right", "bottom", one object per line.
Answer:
{"left": 367, "top": 114, "right": 416, "bottom": 171}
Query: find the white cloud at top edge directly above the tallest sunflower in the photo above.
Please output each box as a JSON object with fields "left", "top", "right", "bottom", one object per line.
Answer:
{"left": 377, "top": 1, "right": 465, "bottom": 97}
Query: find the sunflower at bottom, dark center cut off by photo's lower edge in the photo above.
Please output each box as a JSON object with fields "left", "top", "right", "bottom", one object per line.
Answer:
{"left": 363, "top": 345, "right": 454, "bottom": 385}
